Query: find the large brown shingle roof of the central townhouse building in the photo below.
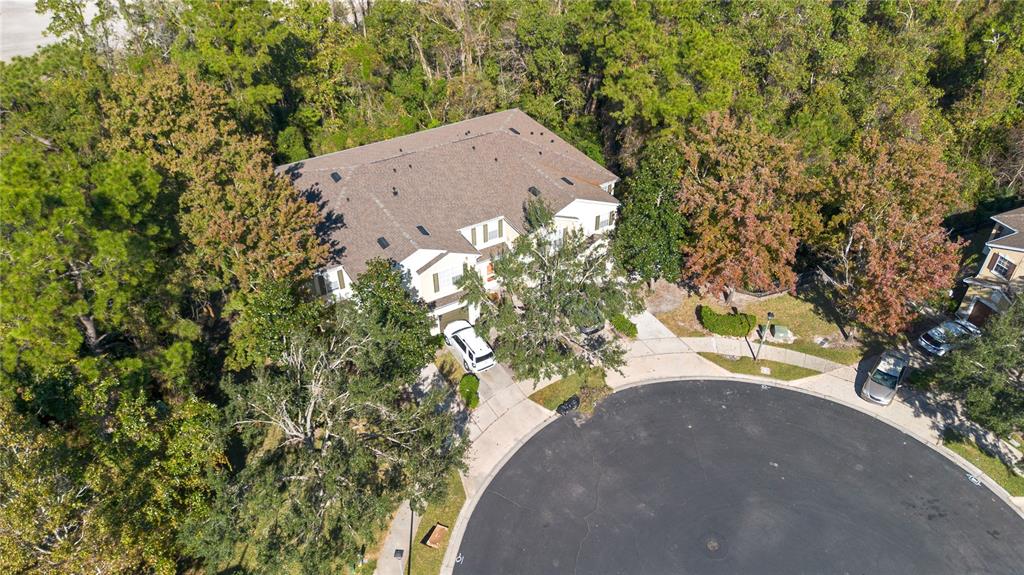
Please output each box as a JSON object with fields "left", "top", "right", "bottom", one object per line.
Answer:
{"left": 278, "top": 109, "right": 618, "bottom": 276}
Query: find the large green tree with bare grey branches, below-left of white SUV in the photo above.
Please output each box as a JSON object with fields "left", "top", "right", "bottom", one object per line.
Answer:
{"left": 187, "top": 301, "right": 466, "bottom": 573}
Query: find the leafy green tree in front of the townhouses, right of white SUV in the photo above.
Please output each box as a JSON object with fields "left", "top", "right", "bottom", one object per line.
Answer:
{"left": 459, "top": 200, "right": 639, "bottom": 381}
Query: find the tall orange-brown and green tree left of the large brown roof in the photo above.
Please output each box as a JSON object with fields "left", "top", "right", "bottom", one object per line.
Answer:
{"left": 103, "top": 65, "right": 327, "bottom": 295}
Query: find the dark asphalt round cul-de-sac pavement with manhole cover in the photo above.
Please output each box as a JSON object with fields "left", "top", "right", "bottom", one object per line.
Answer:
{"left": 455, "top": 382, "right": 1024, "bottom": 575}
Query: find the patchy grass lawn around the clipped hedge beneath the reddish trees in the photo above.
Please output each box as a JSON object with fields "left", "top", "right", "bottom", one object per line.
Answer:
{"left": 656, "top": 294, "right": 864, "bottom": 365}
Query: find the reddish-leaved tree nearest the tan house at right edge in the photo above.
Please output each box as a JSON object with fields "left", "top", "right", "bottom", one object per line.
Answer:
{"left": 819, "top": 133, "right": 962, "bottom": 335}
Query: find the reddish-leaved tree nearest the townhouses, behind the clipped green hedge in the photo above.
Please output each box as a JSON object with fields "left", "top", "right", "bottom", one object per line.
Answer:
{"left": 679, "top": 113, "right": 818, "bottom": 292}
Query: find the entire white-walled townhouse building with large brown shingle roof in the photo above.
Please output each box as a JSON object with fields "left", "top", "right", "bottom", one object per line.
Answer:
{"left": 279, "top": 109, "right": 618, "bottom": 331}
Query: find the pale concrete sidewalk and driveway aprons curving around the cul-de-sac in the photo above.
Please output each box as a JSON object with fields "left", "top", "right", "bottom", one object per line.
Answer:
{"left": 378, "top": 312, "right": 1024, "bottom": 574}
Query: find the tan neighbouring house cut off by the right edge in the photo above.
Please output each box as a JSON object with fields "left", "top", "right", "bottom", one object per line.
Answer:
{"left": 956, "top": 207, "right": 1024, "bottom": 325}
